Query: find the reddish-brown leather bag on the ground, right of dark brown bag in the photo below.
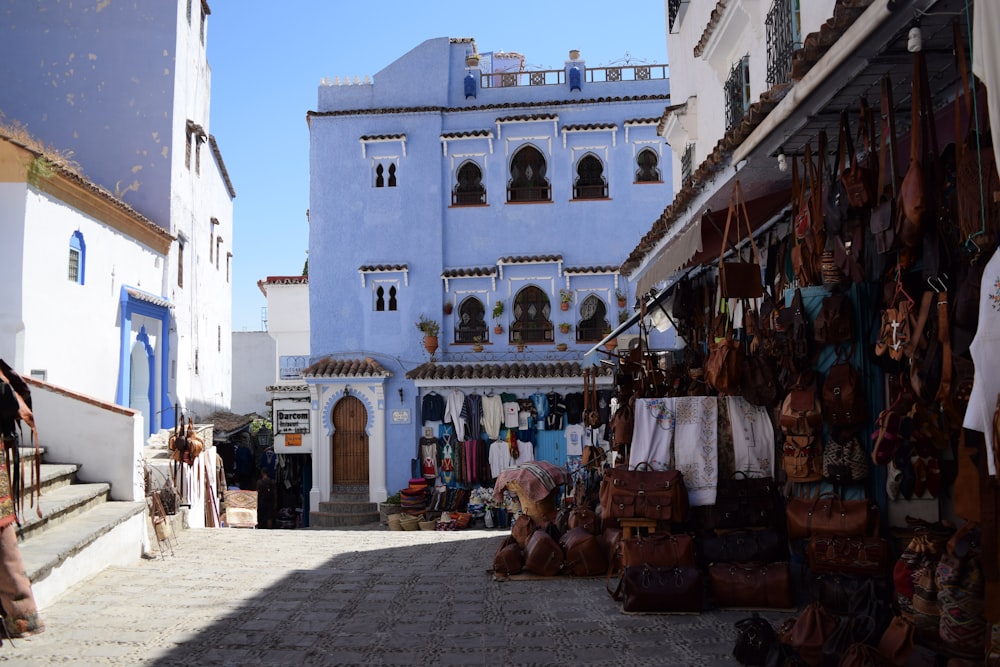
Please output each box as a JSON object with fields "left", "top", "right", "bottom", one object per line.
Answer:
{"left": 708, "top": 563, "right": 794, "bottom": 609}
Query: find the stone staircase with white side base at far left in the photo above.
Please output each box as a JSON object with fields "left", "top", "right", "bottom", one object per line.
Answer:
{"left": 19, "top": 448, "right": 148, "bottom": 610}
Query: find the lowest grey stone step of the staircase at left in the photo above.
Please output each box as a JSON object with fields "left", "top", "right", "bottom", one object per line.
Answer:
{"left": 20, "top": 501, "right": 146, "bottom": 583}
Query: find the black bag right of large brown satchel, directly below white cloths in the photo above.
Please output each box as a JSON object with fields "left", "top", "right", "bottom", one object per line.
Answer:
{"left": 705, "top": 470, "right": 783, "bottom": 528}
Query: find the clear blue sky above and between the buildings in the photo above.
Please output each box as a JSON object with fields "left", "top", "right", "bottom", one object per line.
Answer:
{"left": 208, "top": 0, "right": 667, "bottom": 331}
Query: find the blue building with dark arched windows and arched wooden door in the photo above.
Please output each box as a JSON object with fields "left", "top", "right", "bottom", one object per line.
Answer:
{"left": 302, "top": 37, "right": 673, "bottom": 510}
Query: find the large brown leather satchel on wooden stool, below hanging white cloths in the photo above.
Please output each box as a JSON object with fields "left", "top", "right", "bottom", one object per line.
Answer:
{"left": 599, "top": 467, "right": 691, "bottom": 523}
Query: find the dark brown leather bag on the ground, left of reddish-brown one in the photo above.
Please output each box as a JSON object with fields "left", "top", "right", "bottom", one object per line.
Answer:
{"left": 622, "top": 565, "right": 702, "bottom": 613}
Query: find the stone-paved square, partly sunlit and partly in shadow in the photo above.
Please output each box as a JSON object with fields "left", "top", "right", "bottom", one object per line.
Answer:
{"left": 0, "top": 529, "right": 792, "bottom": 667}
